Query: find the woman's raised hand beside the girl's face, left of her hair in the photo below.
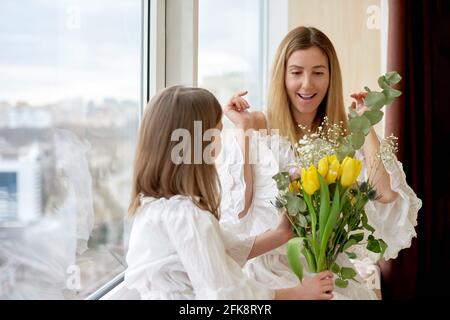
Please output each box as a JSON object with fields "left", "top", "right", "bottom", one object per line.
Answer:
{"left": 224, "top": 91, "right": 253, "bottom": 130}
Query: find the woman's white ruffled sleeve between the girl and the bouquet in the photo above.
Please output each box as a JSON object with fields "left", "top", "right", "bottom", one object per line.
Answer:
{"left": 218, "top": 130, "right": 293, "bottom": 240}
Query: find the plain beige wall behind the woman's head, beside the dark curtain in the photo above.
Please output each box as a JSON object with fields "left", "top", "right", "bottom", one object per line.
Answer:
{"left": 288, "top": 0, "right": 386, "bottom": 134}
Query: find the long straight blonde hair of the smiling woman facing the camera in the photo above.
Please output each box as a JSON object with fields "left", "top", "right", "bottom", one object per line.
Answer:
{"left": 267, "top": 27, "right": 347, "bottom": 143}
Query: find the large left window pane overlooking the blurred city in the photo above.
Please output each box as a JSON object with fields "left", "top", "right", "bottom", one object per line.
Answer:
{"left": 0, "top": 0, "right": 148, "bottom": 299}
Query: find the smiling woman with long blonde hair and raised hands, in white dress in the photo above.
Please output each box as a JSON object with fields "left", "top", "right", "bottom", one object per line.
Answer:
{"left": 221, "top": 27, "right": 421, "bottom": 299}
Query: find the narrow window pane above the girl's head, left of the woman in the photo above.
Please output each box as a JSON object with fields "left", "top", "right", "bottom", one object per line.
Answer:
{"left": 198, "top": 0, "right": 266, "bottom": 114}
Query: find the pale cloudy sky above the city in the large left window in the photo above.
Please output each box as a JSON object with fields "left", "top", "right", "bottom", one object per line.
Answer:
{"left": 0, "top": 0, "right": 141, "bottom": 104}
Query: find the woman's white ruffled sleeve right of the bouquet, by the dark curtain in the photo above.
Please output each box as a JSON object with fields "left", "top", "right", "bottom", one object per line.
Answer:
{"left": 356, "top": 141, "right": 422, "bottom": 260}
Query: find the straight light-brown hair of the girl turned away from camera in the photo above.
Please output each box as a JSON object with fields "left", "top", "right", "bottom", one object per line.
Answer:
{"left": 128, "top": 86, "right": 222, "bottom": 218}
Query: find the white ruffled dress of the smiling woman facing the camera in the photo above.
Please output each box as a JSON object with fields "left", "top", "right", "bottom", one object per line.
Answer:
{"left": 217, "top": 130, "right": 421, "bottom": 299}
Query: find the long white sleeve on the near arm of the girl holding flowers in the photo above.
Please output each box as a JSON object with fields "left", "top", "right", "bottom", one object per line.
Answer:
{"left": 164, "top": 202, "right": 274, "bottom": 300}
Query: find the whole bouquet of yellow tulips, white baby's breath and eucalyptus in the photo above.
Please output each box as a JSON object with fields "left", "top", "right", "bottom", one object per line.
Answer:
{"left": 273, "top": 72, "right": 401, "bottom": 287}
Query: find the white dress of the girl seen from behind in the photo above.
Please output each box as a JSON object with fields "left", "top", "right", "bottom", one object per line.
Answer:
{"left": 125, "top": 196, "right": 274, "bottom": 299}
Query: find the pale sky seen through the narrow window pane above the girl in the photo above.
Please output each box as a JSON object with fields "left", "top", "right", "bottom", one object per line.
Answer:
{"left": 199, "top": 0, "right": 261, "bottom": 78}
